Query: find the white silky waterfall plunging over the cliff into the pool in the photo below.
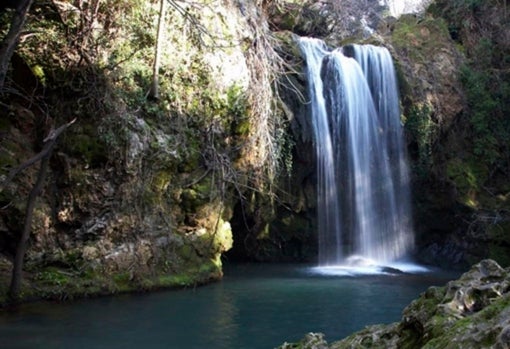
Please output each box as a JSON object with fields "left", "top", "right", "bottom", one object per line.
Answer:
{"left": 300, "top": 38, "right": 414, "bottom": 266}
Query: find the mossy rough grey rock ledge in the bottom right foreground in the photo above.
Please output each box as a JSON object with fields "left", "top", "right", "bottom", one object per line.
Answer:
{"left": 279, "top": 260, "right": 510, "bottom": 349}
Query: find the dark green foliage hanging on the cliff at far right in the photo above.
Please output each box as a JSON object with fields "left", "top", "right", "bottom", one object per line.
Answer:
{"left": 434, "top": 0, "right": 510, "bottom": 205}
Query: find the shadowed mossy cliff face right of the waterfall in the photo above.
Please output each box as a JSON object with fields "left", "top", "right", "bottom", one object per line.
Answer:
{"left": 382, "top": 1, "right": 510, "bottom": 267}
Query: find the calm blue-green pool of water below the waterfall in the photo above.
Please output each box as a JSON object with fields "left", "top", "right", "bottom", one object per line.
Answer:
{"left": 0, "top": 265, "right": 457, "bottom": 349}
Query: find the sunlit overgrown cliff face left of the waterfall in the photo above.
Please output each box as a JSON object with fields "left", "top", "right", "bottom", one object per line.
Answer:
{"left": 0, "top": 0, "right": 294, "bottom": 298}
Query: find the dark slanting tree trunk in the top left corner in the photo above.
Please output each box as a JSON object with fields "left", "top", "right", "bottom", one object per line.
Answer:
{"left": 0, "top": 0, "right": 33, "bottom": 93}
